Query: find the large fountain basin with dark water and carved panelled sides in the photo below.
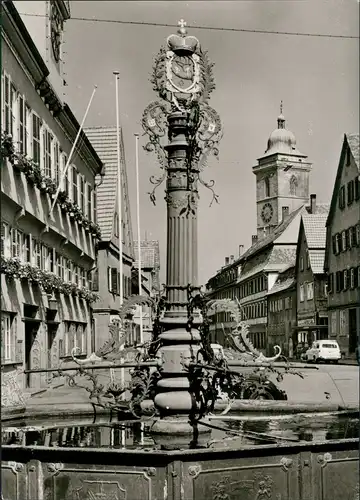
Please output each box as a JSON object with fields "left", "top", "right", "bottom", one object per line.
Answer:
{"left": 2, "top": 414, "right": 359, "bottom": 500}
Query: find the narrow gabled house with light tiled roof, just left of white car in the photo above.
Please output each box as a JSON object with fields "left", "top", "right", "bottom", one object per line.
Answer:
{"left": 294, "top": 209, "right": 328, "bottom": 346}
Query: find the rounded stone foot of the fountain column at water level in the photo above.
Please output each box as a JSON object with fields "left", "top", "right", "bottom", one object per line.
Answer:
{"left": 151, "top": 417, "right": 211, "bottom": 450}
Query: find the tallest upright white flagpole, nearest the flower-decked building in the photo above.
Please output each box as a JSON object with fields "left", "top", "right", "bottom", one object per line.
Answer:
{"left": 113, "top": 71, "right": 125, "bottom": 399}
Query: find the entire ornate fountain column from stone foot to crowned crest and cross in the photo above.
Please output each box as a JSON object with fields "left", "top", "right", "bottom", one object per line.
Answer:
{"left": 142, "top": 21, "right": 221, "bottom": 447}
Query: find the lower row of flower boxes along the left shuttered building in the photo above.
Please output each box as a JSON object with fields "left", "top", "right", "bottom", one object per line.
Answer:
{"left": 0, "top": 257, "right": 100, "bottom": 303}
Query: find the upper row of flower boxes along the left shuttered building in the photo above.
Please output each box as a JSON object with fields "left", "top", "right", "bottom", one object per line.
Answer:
{"left": 1, "top": 133, "right": 101, "bottom": 240}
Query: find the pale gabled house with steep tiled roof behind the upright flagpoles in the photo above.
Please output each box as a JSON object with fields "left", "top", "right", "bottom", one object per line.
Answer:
{"left": 86, "top": 127, "right": 134, "bottom": 350}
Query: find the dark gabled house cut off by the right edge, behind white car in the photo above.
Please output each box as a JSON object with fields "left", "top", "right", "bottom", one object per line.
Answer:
{"left": 325, "top": 134, "right": 360, "bottom": 356}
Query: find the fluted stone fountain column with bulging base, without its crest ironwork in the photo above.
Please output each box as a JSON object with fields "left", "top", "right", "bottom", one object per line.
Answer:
{"left": 152, "top": 112, "right": 211, "bottom": 448}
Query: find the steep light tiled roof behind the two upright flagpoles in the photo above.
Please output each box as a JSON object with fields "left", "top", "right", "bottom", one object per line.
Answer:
{"left": 85, "top": 127, "right": 133, "bottom": 253}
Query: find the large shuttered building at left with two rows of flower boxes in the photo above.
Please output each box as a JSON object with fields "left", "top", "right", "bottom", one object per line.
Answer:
{"left": 1, "top": 1, "right": 103, "bottom": 388}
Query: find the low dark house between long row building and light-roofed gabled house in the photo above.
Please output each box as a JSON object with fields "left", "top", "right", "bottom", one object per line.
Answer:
{"left": 267, "top": 264, "right": 296, "bottom": 359}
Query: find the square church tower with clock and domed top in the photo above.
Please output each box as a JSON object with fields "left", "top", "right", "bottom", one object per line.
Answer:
{"left": 252, "top": 103, "right": 312, "bottom": 238}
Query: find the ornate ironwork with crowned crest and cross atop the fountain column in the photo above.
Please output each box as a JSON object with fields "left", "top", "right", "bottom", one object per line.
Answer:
{"left": 142, "top": 19, "right": 222, "bottom": 205}
